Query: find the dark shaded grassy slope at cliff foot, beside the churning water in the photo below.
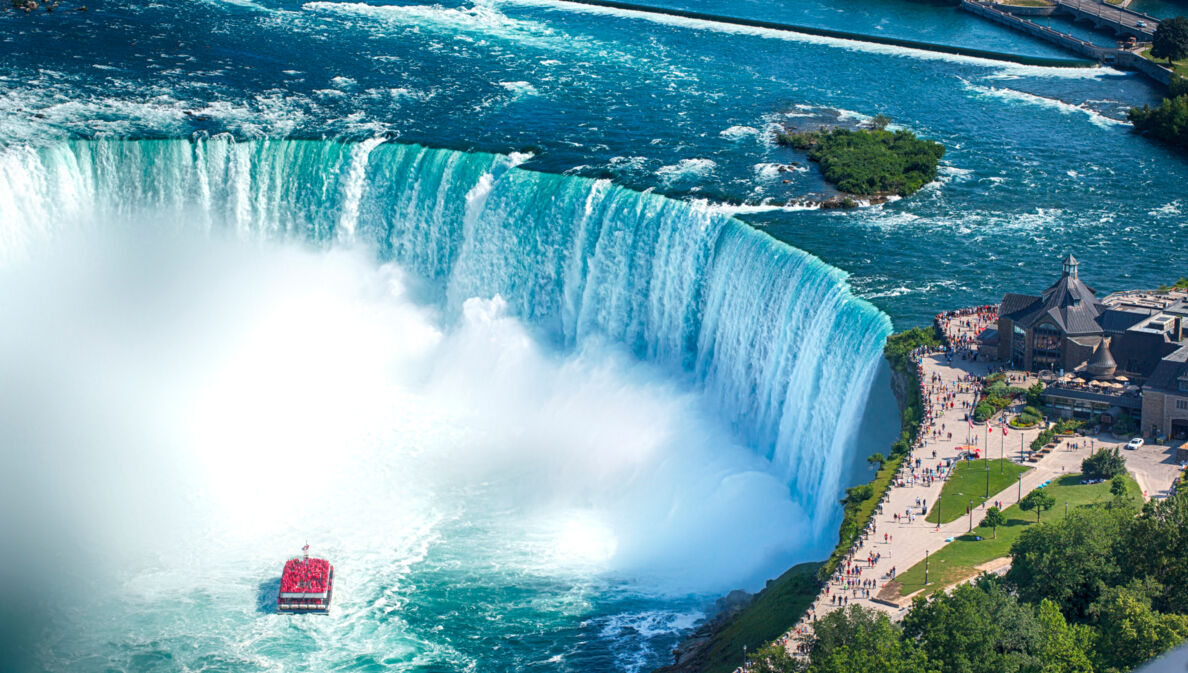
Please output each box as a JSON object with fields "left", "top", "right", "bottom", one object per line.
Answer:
{"left": 700, "top": 564, "right": 821, "bottom": 673}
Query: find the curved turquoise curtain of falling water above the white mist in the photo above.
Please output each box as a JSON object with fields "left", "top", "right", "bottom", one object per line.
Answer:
{"left": 0, "top": 136, "right": 890, "bottom": 533}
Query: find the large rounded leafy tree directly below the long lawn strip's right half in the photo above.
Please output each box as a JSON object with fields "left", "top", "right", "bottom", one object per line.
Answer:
{"left": 1004, "top": 508, "right": 1131, "bottom": 621}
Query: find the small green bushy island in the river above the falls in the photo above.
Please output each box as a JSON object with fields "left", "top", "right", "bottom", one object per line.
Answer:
{"left": 776, "top": 115, "right": 944, "bottom": 206}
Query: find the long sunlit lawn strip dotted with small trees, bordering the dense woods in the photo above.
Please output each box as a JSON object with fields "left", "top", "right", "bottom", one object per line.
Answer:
{"left": 896, "top": 474, "right": 1143, "bottom": 596}
